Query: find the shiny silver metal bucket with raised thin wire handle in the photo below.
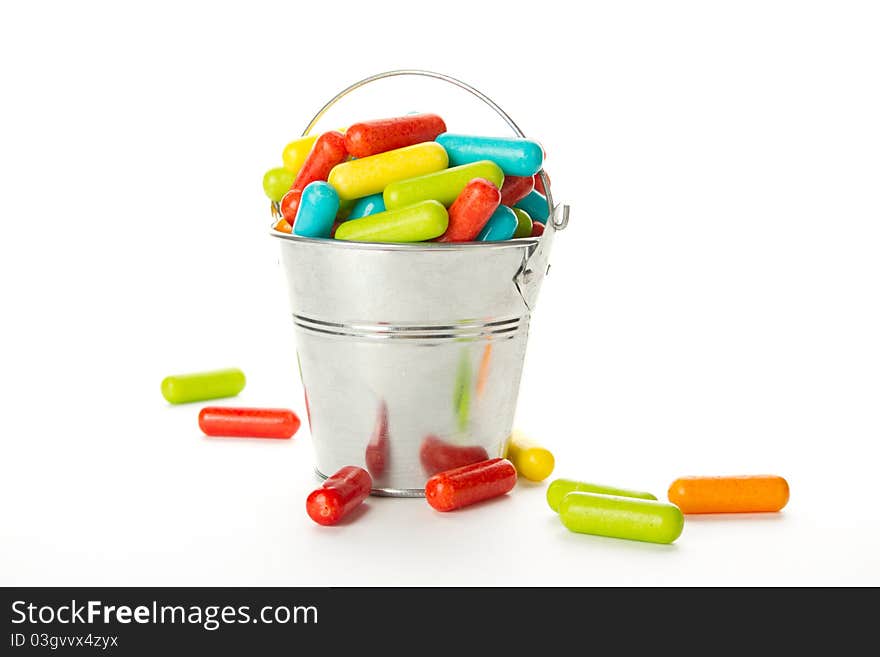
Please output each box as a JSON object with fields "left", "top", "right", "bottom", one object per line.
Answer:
{"left": 272, "top": 70, "right": 568, "bottom": 497}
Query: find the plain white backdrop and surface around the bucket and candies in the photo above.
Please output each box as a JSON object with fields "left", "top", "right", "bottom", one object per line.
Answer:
{"left": 0, "top": 0, "right": 880, "bottom": 585}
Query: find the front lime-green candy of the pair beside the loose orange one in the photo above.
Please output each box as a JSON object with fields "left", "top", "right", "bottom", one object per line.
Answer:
{"left": 559, "top": 492, "right": 684, "bottom": 543}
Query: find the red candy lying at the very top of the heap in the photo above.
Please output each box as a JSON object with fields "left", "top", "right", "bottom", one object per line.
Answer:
{"left": 345, "top": 114, "right": 446, "bottom": 157}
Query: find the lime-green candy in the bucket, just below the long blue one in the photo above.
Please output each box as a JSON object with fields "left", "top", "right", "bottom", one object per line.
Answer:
{"left": 384, "top": 160, "right": 504, "bottom": 210}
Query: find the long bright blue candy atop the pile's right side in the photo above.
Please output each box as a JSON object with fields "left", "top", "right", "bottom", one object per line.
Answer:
{"left": 437, "top": 132, "right": 544, "bottom": 176}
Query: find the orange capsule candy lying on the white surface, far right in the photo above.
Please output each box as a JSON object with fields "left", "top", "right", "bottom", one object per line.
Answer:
{"left": 668, "top": 475, "right": 789, "bottom": 513}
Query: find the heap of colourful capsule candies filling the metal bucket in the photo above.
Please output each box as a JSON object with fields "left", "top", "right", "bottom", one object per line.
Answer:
{"left": 263, "top": 114, "right": 550, "bottom": 242}
